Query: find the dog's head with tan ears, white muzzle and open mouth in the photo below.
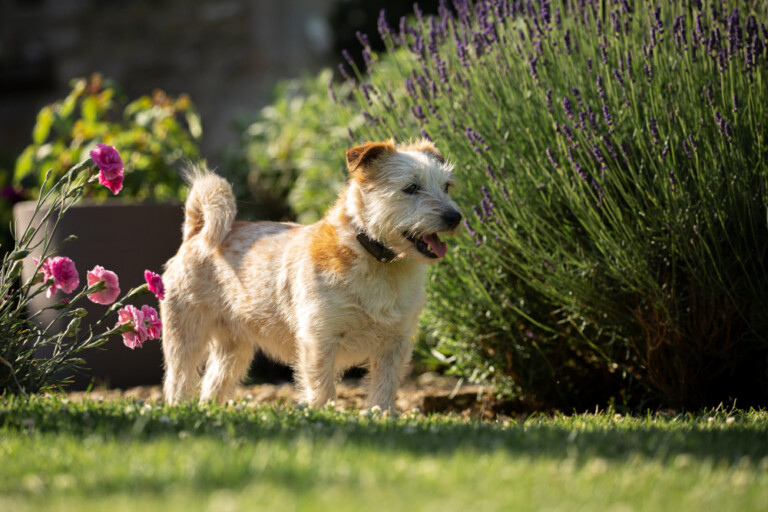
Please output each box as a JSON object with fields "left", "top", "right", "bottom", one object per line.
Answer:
{"left": 346, "top": 140, "right": 462, "bottom": 263}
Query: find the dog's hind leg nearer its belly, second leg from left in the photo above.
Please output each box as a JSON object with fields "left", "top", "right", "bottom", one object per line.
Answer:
{"left": 200, "top": 330, "right": 254, "bottom": 403}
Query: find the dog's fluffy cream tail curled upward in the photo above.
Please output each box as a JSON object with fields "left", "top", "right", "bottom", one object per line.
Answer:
{"left": 184, "top": 162, "right": 237, "bottom": 247}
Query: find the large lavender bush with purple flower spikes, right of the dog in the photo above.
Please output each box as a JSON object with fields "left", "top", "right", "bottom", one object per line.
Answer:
{"left": 336, "top": 0, "right": 768, "bottom": 407}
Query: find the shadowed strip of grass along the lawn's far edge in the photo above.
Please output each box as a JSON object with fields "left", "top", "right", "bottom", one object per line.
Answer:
{"left": 0, "top": 398, "right": 768, "bottom": 464}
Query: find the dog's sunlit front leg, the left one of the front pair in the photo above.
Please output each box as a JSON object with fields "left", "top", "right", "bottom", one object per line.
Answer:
{"left": 296, "top": 339, "right": 336, "bottom": 407}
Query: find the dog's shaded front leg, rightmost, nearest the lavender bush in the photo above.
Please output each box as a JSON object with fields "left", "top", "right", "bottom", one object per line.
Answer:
{"left": 368, "top": 336, "right": 413, "bottom": 412}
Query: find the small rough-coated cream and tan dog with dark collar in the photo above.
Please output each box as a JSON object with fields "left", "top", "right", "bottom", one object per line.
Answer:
{"left": 161, "top": 140, "right": 462, "bottom": 411}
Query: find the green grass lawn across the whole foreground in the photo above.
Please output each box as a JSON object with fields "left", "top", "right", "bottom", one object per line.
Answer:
{"left": 0, "top": 397, "right": 768, "bottom": 512}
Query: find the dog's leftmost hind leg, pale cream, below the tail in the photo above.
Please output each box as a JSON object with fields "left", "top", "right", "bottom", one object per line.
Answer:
{"left": 161, "top": 306, "right": 208, "bottom": 404}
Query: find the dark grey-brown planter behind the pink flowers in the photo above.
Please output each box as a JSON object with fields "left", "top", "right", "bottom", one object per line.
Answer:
{"left": 13, "top": 200, "right": 184, "bottom": 389}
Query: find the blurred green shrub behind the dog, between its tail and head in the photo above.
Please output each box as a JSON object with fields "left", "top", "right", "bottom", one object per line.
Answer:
{"left": 223, "top": 69, "right": 360, "bottom": 223}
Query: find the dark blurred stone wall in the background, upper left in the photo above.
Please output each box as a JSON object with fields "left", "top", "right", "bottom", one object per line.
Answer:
{"left": 0, "top": 0, "right": 338, "bottom": 169}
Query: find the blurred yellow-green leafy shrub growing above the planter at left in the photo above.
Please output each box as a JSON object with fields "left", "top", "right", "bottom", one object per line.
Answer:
{"left": 14, "top": 75, "right": 202, "bottom": 201}
